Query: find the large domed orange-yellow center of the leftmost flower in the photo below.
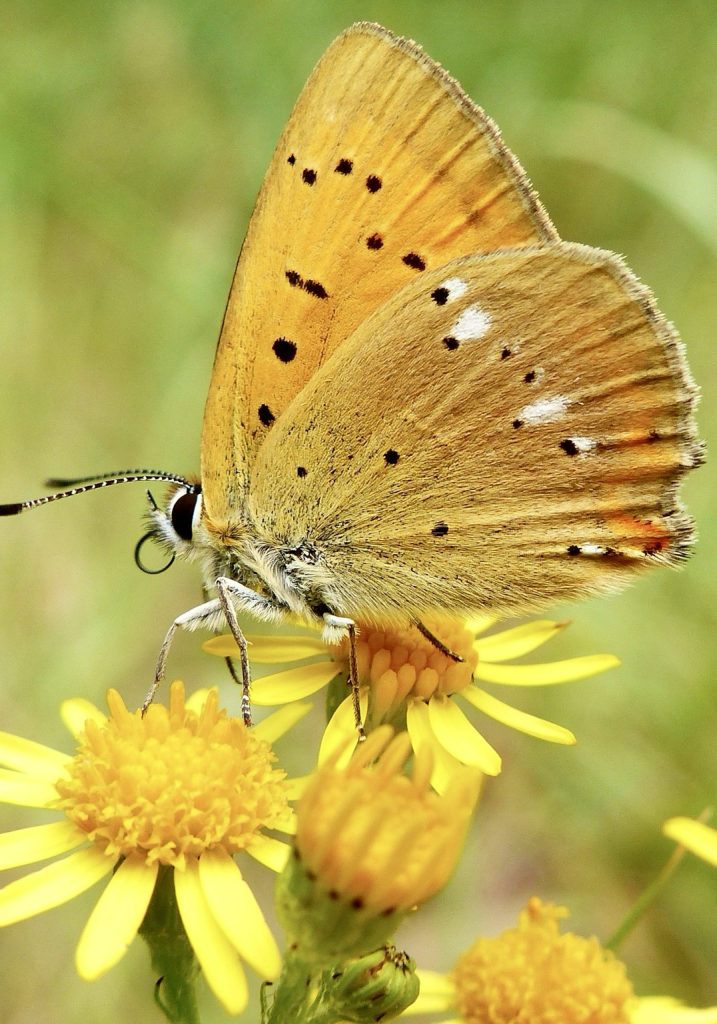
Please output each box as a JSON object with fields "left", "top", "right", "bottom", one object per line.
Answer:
{"left": 56, "top": 683, "right": 288, "bottom": 867}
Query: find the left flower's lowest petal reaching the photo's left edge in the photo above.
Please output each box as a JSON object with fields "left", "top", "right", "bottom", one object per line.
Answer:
{"left": 0, "top": 846, "right": 115, "bottom": 926}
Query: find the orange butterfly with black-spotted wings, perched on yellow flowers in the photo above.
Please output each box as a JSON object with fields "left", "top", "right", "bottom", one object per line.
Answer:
{"left": 0, "top": 23, "right": 702, "bottom": 712}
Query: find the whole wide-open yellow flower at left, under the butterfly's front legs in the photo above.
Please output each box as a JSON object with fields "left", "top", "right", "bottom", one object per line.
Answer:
{"left": 0, "top": 682, "right": 308, "bottom": 1013}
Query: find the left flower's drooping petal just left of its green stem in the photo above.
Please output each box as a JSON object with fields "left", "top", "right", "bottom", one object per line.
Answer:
{"left": 75, "top": 855, "right": 159, "bottom": 981}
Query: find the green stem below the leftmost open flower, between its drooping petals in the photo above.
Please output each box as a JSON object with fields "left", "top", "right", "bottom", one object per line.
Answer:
{"left": 139, "top": 865, "right": 201, "bottom": 1024}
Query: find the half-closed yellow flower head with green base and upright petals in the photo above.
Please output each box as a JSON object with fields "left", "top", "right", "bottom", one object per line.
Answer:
{"left": 277, "top": 725, "right": 480, "bottom": 963}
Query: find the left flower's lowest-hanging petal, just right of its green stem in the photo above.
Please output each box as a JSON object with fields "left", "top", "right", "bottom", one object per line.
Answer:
{"left": 174, "top": 858, "right": 249, "bottom": 1014}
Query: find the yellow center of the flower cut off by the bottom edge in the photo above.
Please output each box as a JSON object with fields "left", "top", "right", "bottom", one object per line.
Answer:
{"left": 453, "top": 897, "right": 634, "bottom": 1024}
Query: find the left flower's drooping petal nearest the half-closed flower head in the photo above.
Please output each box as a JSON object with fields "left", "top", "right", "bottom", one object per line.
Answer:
{"left": 199, "top": 847, "right": 282, "bottom": 981}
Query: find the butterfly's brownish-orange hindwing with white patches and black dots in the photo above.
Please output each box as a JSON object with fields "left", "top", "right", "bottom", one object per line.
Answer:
{"left": 250, "top": 243, "right": 701, "bottom": 620}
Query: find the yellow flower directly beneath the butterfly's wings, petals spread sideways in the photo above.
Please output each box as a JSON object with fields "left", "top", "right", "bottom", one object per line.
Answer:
{"left": 204, "top": 617, "right": 620, "bottom": 792}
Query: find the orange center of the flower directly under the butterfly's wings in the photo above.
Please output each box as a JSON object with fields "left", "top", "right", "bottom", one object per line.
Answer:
{"left": 335, "top": 621, "right": 478, "bottom": 708}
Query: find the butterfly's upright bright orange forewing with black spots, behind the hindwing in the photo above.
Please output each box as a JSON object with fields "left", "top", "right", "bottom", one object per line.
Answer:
{"left": 202, "top": 24, "right": 556, "bottom": 521}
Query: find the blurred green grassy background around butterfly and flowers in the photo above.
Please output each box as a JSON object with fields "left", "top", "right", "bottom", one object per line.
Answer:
{"left": 0, "top": 0, "right": 717, "bottom": 1024}
